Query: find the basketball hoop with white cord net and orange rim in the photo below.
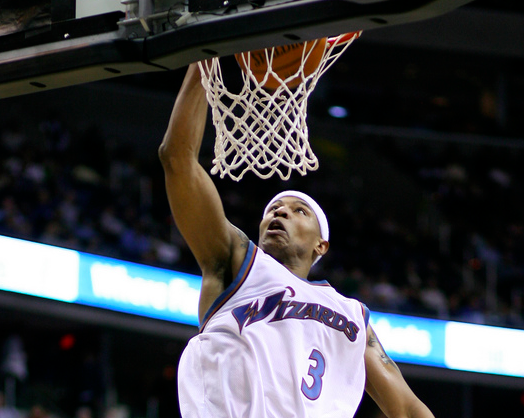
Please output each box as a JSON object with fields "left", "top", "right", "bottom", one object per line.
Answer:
{"left": 199, "top": 31, "right": 362, "bottom": 181}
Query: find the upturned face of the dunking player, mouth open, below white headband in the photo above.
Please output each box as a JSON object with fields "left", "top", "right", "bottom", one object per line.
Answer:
{"left": 259, "top": 196, "right": 322, "bottom": 264}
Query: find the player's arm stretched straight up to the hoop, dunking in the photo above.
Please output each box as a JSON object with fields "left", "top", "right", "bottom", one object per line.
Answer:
{"left": 159, "top": 64, "right": 247, "bottom": 318}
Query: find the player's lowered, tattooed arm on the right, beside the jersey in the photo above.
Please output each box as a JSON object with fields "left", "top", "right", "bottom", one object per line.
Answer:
{"left": 365, "top": 325, "right": 434, "bottom": 418}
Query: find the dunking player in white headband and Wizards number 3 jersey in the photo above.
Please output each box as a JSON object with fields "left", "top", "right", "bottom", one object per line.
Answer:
{"left": 159, "top": 64, "right": 433, "bottom": 418}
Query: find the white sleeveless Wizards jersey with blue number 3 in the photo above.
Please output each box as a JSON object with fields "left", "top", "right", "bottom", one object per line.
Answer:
{"left": 178, "top": 242, "right": 369, "bottom": 418}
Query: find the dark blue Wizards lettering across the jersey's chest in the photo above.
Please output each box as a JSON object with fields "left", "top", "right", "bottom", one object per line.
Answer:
{"left": 232, "top": 287, "right": 360, "bottom": 342}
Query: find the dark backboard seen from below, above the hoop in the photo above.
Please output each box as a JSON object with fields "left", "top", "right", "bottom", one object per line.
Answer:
{"left": 0, "top": 0, "right": 471, "bottom": 98}
